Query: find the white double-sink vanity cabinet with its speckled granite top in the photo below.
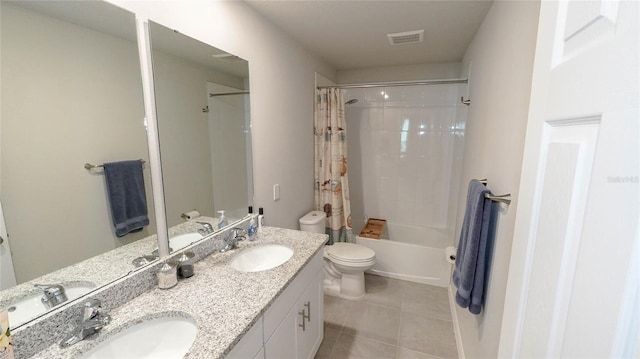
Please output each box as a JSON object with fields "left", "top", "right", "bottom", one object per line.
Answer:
{"left": 24, "top": 227, "right": 327, "bottom": 359}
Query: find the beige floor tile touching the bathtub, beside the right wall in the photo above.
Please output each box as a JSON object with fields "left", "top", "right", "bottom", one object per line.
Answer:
{"left": 401, "top": 285, "right": 452, "bottom": 321}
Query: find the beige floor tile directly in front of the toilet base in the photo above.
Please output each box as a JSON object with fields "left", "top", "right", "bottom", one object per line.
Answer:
{"left": 342, "top": 302, "right": 401, "bottom": 345}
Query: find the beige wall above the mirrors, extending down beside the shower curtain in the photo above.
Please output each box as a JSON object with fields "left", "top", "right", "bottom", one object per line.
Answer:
{"left": 110, "top": 0, "right": 335, "bottom": 228}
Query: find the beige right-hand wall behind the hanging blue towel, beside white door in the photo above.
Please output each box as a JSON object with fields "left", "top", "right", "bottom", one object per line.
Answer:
{"left": 451, "top": 1, "right": 539, "bottom": 358}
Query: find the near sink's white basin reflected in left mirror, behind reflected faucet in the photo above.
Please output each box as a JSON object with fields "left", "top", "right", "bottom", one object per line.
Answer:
{"left": 8, "top": 284, "right": 94, "bottom": 328}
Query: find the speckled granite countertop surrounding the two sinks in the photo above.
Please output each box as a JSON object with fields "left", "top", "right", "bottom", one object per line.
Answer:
{"left": 34, "top": 227, "right": 327, "bottom": 359}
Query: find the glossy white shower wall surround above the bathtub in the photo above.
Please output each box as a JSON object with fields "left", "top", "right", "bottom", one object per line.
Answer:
{"left": 345, "top": 84, "right": 467, "bottom": 241}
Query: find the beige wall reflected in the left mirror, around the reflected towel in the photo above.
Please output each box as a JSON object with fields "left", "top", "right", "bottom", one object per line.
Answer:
{"left": 0, "top": 2, "right": 155, "bottom": 283}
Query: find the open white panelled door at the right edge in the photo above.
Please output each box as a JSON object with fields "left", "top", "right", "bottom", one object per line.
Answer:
{"left": 500, "top": 0, "right": 640, "bottom": 358}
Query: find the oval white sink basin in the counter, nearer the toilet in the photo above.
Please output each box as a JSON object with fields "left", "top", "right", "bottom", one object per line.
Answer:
{"left": 230, "top": 244, "right": 293, "bottom": 272}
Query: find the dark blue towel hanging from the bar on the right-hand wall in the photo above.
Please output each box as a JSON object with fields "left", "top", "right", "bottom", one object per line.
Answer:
{"left": 453, "top": 180, "right": 491, "bottom": 314}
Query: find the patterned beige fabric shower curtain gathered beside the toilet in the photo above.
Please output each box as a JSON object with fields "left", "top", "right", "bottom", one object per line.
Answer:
{"left": 314, "top": 88, "right": 354, "bottom": 244}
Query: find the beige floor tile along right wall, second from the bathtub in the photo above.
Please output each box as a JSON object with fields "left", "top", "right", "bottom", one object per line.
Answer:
{"left": 398, "top": 313, "right": 458, "bottom": 358}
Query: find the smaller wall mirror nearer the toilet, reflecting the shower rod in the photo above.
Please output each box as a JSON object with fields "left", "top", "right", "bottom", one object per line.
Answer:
{"left": 149, "top": 22, "right": 253, "bottom": 250}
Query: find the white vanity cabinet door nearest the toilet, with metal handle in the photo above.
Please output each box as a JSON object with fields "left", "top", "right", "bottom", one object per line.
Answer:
{"left": 295, "top": 271, "right": 324, "bottom": 359}
